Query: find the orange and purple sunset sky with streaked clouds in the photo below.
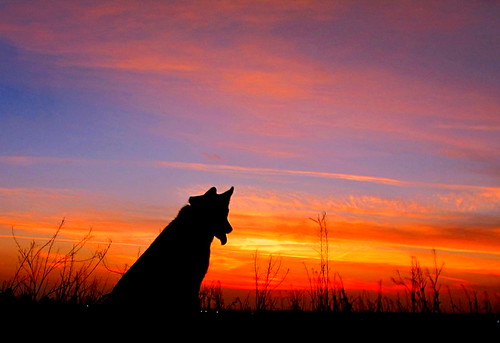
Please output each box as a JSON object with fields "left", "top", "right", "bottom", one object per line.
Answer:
{"left": 0, "top": 0, "right": 500, "bottom": 300}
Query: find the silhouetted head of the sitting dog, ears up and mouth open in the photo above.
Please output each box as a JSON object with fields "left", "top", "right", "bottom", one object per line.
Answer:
{"left": 189, "top": 187, "right": 234, "bottom": 245}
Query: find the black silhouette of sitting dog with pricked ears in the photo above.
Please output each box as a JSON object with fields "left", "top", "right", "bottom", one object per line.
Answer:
{"left": 106, "top": 187, "right": 234, "bottom": 313}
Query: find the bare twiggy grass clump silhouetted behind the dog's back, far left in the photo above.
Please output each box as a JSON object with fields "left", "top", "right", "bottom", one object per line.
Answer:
{"left": 1, "top": 220, "right": 111, "bottom": 304}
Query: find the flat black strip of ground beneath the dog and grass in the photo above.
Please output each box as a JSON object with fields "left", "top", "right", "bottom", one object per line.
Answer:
{"left": 0, "top": 304, "right": 500, "bottom": 342}
